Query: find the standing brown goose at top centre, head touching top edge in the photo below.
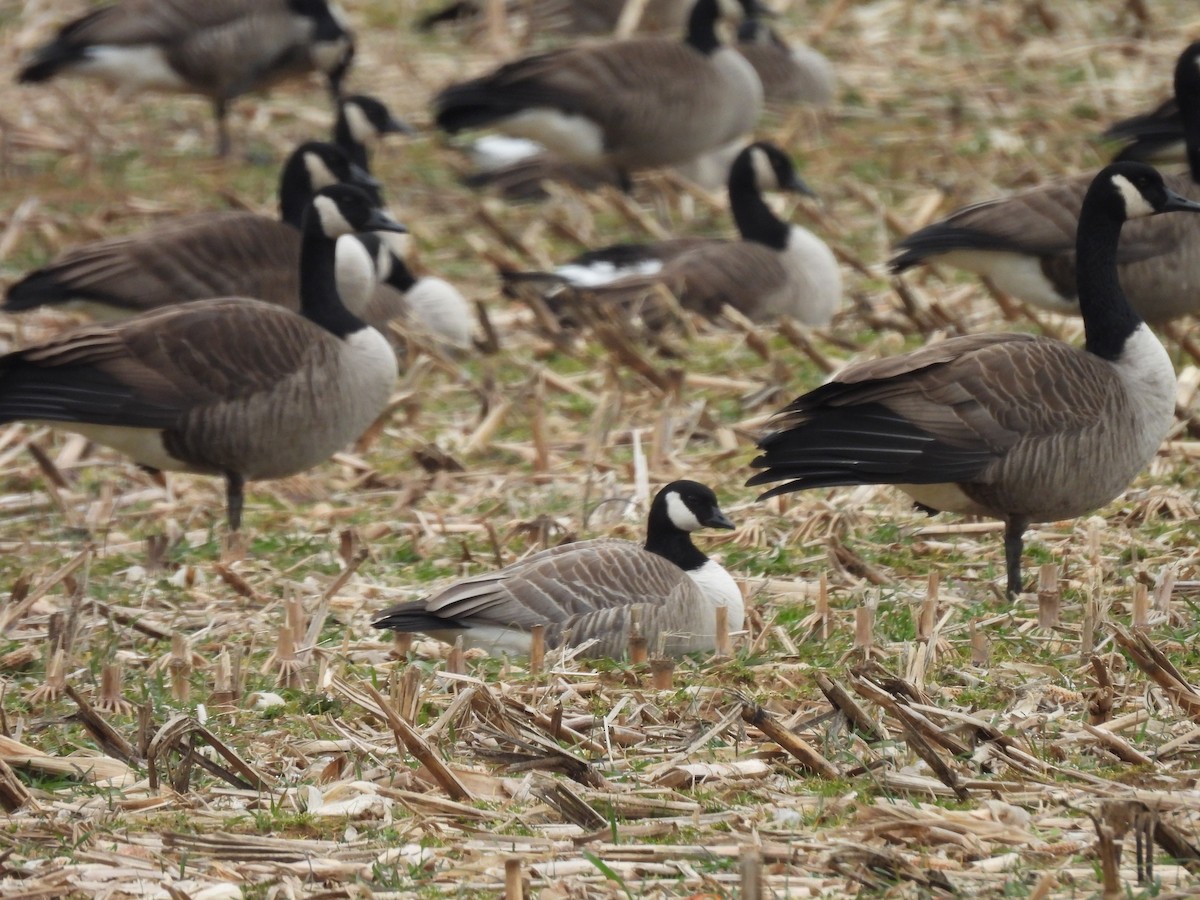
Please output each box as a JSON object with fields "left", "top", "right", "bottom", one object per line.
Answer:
{"left": 433, "top": 0, "right": 762, "bottom": 186}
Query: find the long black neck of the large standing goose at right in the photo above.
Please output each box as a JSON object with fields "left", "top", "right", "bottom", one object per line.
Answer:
{"left": 1075, "top": 184, "right": 1141, "bottom": 361}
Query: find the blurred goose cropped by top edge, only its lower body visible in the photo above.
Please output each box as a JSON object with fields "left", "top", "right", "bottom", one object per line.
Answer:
{"left": 416, "top": 0, "right": 692, "bottom": 35}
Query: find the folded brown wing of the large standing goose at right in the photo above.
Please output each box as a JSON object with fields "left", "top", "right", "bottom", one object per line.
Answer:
{"left": 748, "top": 335, "right": 1111, "bottom": 496}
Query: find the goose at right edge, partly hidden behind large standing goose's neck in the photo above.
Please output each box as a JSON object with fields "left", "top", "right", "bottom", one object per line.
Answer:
{"left": 889, "top": 42, "right": 1200, "bottom": 325}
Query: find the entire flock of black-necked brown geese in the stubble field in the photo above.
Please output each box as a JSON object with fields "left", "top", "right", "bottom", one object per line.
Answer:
{"left": 0, "top": 0, "right": 1200, "bottom": 656}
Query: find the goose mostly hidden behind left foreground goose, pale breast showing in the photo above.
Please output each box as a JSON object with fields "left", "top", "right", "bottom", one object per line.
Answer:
{"left": 350, "top": 232, "right": 475, "bottom": 349}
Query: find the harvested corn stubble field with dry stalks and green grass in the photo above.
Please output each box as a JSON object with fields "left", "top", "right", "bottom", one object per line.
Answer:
{"left": 0, "top": 0, "right": 1200, "bottom": 898}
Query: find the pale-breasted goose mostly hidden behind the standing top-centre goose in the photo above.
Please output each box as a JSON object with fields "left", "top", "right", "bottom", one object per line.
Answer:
{"left": 736, "top": 16, "right": 836, "bottom": 107}
